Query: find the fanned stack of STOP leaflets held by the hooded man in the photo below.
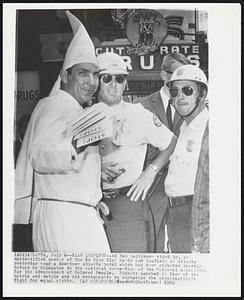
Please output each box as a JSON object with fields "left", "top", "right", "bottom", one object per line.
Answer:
{"left": 70, "top": 103, "right": 112, "bottom": 147}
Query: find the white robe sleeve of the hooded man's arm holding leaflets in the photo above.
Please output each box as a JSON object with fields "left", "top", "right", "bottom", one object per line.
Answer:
{"left": 29, "top": 101, "right": 84, "bottom": 174}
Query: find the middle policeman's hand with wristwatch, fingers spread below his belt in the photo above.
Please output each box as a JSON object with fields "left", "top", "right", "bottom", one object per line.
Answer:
{"left": 126, "top": 167, "right": 157, "bottom": 201}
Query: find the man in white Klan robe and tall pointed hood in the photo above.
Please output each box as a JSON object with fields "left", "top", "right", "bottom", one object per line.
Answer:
{"left": 14, "top": 11, "right": 110, "bottom": 252}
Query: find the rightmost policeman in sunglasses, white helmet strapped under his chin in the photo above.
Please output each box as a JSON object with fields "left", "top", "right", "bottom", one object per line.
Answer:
{"left": 165, "top": 65, "right": 209, "bottom": 252}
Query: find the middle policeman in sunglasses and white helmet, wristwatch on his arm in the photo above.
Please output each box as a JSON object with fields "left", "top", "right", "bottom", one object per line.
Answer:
{"left": 98, "top": 53, "right": 176, "bottom": 252}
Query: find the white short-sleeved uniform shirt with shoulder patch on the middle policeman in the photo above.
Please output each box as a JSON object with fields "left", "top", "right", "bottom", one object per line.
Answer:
{"left": 100, "top": 101, "right": 173, "bottom": 189}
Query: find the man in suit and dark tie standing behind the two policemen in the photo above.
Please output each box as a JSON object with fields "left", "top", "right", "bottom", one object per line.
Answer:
{"left": 135, "top": 53, "right": 191, "bottom": 253}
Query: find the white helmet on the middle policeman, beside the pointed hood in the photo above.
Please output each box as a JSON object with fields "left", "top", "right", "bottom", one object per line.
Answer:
{"left": 97, "top": 52, "right": 129, "bottom": 75}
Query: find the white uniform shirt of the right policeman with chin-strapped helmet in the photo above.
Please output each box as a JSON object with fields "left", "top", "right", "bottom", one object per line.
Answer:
{"left": 165, "top": 108, "right": 208, "bottom": 197}
